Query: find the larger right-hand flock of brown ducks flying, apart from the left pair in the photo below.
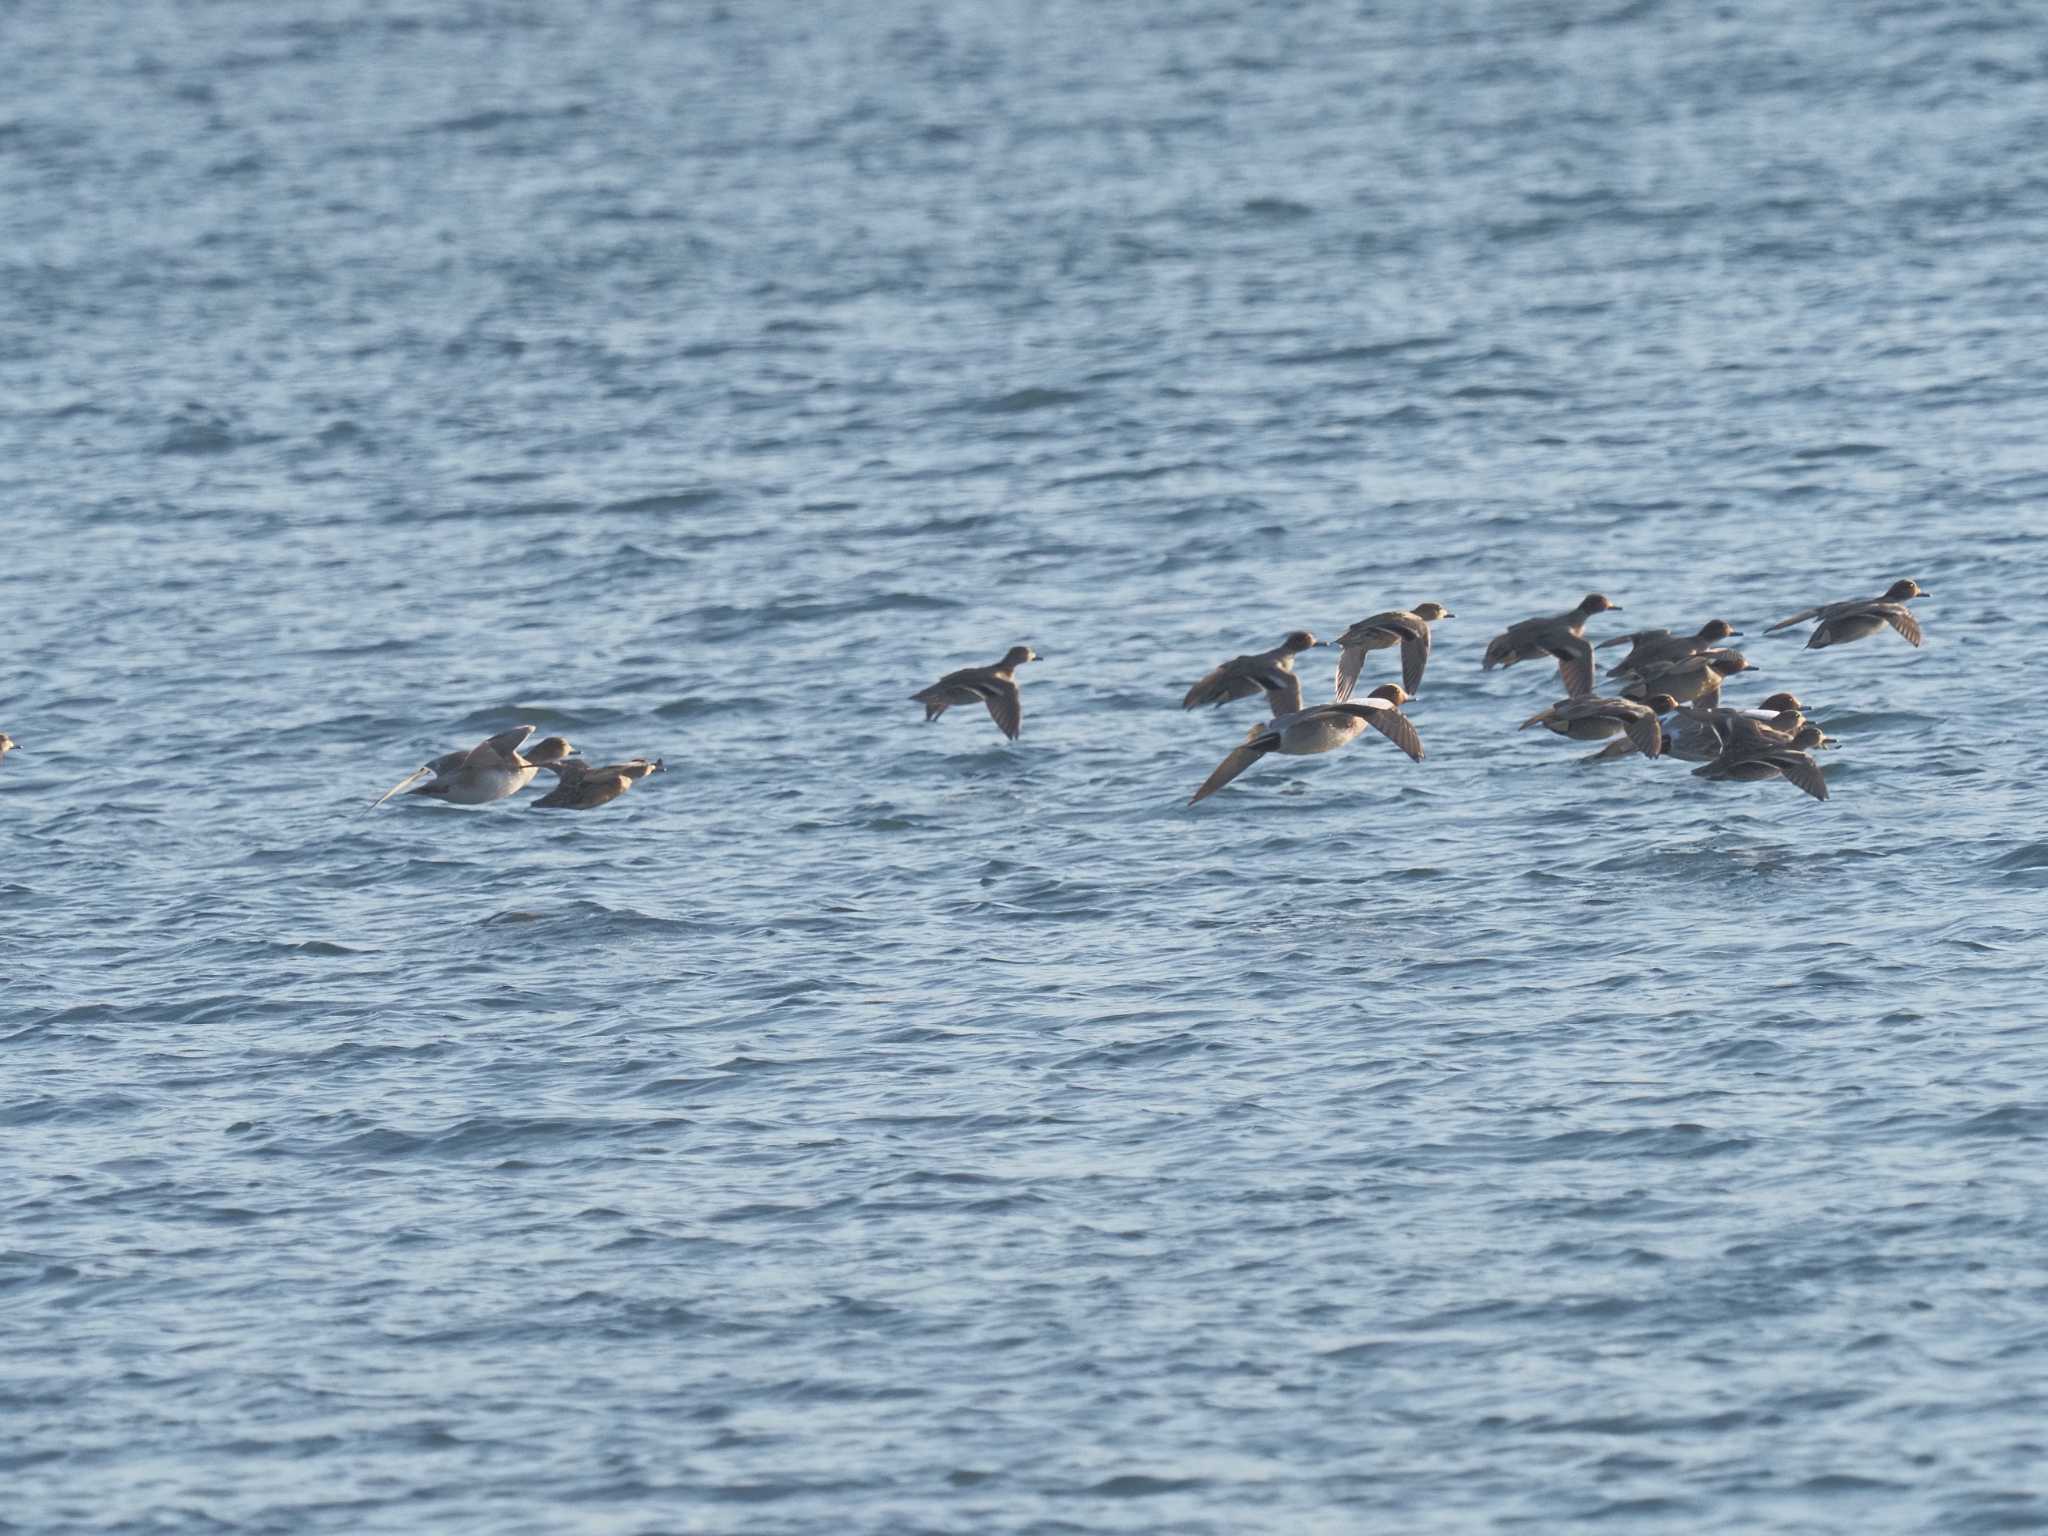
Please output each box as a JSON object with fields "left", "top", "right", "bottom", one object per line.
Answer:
{"left": 911, "top": 580, "right": 1927, "bottom": 805}
